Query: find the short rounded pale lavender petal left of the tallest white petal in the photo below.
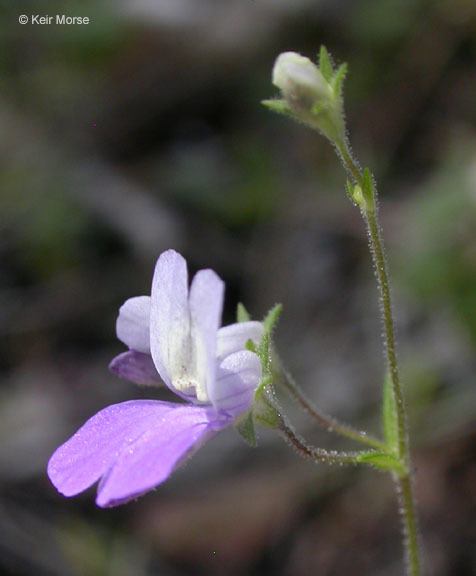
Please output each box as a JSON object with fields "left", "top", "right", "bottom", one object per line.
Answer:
{"left": 116, "top": 296, "right": 150, "bottom": 354}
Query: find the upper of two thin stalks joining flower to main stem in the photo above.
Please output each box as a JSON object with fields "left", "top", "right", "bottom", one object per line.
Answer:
{"left": 280, "top": 370, "right": 387, "bottom": 450}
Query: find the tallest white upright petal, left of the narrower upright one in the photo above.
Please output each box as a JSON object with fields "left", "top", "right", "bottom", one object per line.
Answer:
{"left": 150, "top": 250, "right": 190, "bottom": 389}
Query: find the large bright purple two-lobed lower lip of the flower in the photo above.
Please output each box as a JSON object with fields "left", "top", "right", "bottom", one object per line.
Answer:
{"left": 47, "top": 400, "right": 222, "bottom": 505}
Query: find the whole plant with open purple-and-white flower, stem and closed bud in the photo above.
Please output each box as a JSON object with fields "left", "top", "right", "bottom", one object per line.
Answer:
{"left": 47, "top": 48, "right": 420, "bottom": 576}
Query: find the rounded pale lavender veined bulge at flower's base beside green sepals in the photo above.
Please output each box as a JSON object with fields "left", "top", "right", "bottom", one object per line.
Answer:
{"left": 214, "top": 350, "right": 261, "bottom": 418}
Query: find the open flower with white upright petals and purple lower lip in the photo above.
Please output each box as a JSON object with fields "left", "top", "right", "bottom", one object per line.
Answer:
{"left": 48, "top": 250, "right": 263, "bottom": 507}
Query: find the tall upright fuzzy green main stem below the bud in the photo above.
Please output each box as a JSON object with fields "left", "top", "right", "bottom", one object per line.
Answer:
{"left": 337, "top": 142, "right": 420, "bottom": 576}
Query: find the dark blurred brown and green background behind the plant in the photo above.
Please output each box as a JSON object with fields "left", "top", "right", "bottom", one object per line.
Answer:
{"left": 0, "top": 0, "right": 476, "bottom": 576}
